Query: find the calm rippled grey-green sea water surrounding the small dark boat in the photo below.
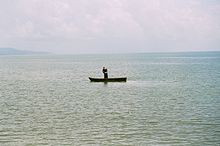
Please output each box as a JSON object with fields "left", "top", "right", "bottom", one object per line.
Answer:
{"left": 0, "top": 52, "right": 220, "bottom": 146}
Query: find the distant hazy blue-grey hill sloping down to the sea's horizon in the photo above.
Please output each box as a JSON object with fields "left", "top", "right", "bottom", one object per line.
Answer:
{"left": 0, "top": 48, "right": 49, "bottom": 55}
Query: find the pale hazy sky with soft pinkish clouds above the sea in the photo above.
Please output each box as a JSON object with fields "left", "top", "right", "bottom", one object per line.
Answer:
{"left": 0, "top": 0, "right": 220, "bottom": 53}
